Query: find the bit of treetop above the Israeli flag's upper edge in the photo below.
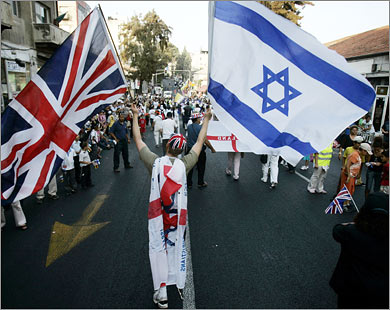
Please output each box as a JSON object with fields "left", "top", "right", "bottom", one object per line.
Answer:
{"left": 259, "top": 1, "right": 314, "bottom": 26}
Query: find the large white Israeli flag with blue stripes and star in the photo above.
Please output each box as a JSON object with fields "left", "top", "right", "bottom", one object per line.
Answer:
{"left": 208, "top": 1, "right": 375, "bottom": 166}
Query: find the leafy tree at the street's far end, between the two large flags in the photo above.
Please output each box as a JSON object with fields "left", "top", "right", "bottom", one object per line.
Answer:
{"left": 119, "top": 10, "right": 175, "bottom": 86}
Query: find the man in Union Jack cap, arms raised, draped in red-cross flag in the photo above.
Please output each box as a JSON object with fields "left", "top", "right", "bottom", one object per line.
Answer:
{"left": 132, "top": 105, "right": 212, "bottom": 309}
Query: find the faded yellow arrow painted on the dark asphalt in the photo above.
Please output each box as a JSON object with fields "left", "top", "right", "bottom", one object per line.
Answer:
{"left": 46, "top": 195, "right": 110, "bottom": 267}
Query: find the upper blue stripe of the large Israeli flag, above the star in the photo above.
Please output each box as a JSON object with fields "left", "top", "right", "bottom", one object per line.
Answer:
{"left": 215, "top": 1, "right": 375, "bottom": 111}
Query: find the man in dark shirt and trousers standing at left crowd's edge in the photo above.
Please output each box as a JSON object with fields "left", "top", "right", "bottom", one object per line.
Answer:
{"left": 110, "top": 114, "right": 133, "bottom": 172}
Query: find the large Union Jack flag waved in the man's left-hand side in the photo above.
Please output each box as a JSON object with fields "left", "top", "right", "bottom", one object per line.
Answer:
{"left": 1, "top": 8, "right": 126, "bottom": 204}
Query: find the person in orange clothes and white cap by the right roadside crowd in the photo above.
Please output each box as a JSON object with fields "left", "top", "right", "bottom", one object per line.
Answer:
{"left": 338, "top": 139, "right": 372, "bottom": 212}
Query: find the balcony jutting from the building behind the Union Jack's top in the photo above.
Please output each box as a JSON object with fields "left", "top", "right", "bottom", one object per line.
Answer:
{"left": 33, "top": 23, "right": 69, "bottom": 48}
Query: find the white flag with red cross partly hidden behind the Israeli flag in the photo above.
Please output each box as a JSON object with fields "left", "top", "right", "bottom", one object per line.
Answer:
{"left": 207, "top": 121, "right": 252, "bottom": 152}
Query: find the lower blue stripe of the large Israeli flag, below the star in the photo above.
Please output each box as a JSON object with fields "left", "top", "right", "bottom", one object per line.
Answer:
{"left": 208, "top": 78, "right": 317, "bottom": 156}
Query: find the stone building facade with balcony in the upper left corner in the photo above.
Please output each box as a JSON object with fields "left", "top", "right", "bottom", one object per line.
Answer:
{"left": 0, "top": 0, "right": 69, "bottom": 111}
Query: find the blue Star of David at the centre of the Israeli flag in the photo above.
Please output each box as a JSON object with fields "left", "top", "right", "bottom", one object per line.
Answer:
{"left": 252, "top": 65, "right": 301, "bottom": 116}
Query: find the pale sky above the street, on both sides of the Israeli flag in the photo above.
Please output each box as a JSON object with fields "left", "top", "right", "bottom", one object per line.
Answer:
{"left": 87, "top": 1, "right": 389, "bottom": 53}
